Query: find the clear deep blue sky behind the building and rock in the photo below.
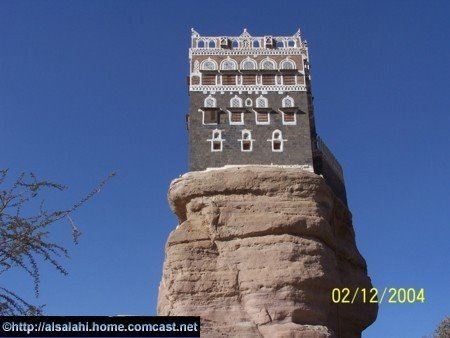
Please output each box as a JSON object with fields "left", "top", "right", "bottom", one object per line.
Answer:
{"left": 0, "top": 0, "right": 450, "bottom": 338}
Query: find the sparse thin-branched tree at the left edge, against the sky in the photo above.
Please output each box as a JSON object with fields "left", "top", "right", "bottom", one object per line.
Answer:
{"left": 0, "top": 169, "right": 115, "bottom": 316}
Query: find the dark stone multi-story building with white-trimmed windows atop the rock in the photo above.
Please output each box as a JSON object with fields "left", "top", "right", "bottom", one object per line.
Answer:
{"left": 187, "top": 29, "right": 346, "bottom": 203}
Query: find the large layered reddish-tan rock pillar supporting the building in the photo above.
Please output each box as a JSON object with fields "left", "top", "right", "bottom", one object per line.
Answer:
{"left": 158, "top": 166, "right": 377, "bottom": 338}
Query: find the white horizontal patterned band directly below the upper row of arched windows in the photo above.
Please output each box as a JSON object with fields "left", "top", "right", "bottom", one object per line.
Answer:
{"left": 189, "top": 84, "right": 306, "bottom": 93}
